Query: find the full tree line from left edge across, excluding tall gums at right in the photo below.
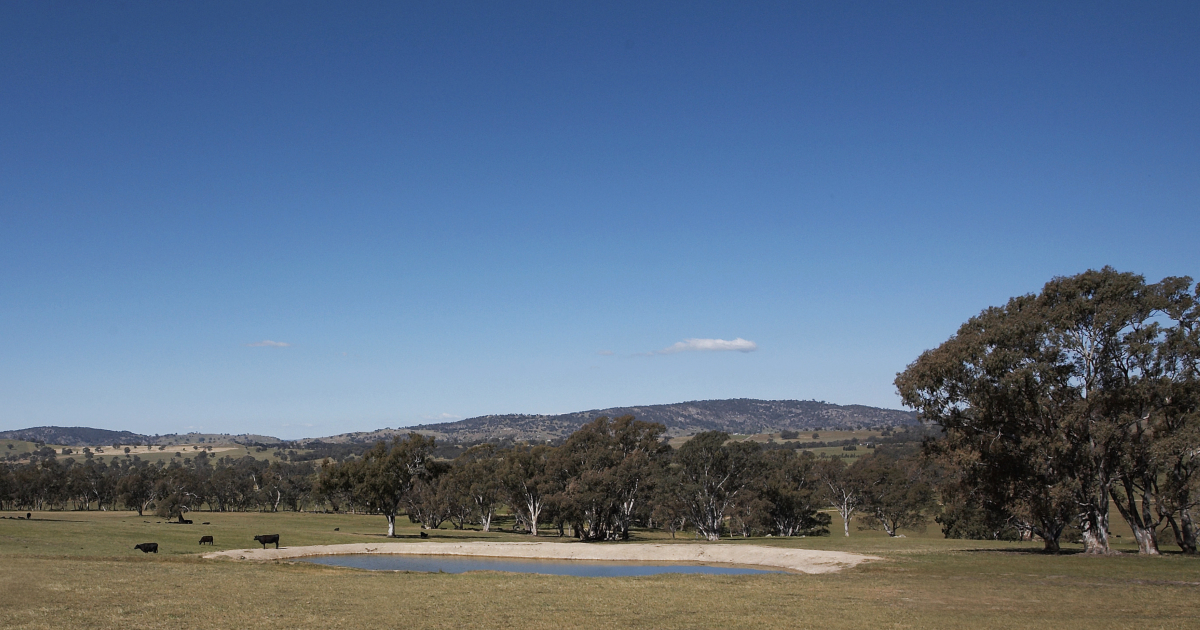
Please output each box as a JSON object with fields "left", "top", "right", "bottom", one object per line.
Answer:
{"left": 0, "top": 416, "right": 936, "bottom": 540}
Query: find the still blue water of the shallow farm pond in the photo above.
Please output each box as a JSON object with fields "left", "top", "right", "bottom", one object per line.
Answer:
{"left": 298, "top": 553, "right": 785, "bottom": 577}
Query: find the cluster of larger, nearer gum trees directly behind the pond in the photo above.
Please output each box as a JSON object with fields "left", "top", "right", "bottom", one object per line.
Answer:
{"left": 317, "top": 416, "right": 936, "bottom": 540}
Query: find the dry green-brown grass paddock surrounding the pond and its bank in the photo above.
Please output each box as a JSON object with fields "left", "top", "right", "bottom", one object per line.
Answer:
{"left": 0, "top": 512, "right": 1200, "bottom": 630}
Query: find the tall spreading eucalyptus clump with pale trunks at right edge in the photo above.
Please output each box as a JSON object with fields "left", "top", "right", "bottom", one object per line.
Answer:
{"left": 896, "top": 268, "right": 1200, "bottom": 553}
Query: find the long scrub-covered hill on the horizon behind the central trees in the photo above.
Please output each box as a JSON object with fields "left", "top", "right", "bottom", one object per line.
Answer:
{"left": 388, "top": 398, "right": 919, "bottom": 442}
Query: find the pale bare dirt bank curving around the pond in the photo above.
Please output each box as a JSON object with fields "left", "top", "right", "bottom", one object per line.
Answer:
{"left": 204, "top": 542, "right": 880, "bottom": 574}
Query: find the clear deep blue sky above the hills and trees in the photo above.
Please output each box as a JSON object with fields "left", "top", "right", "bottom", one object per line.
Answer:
{"left": 0, "top": 1, "right": 1200, "bottom": 437}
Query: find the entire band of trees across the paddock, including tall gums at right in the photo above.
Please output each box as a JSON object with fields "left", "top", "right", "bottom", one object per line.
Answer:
{"left": 0, "top": 268, "right": 1200, "bottom": 554}
